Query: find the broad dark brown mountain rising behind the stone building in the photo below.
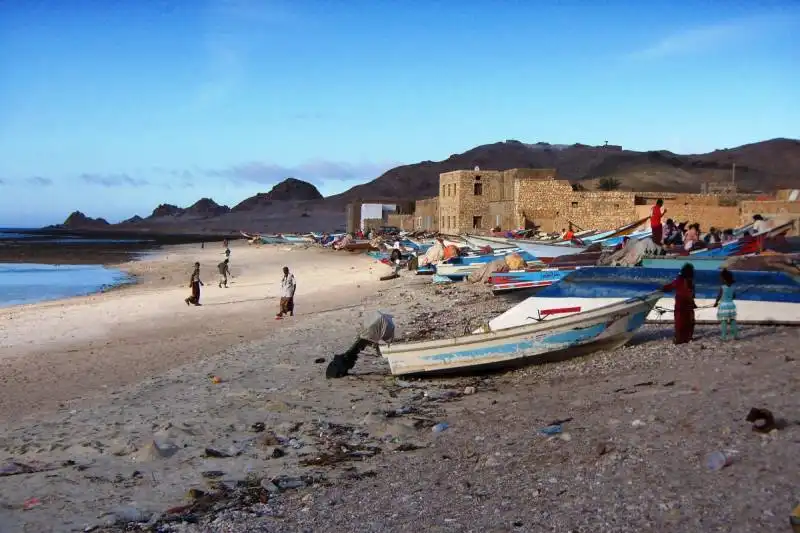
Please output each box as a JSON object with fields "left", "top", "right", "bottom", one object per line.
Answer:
{"left": 327, "top": 139, "right": 800, "bottom": 202}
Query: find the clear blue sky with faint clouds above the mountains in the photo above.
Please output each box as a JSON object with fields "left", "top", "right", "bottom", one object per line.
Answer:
{"left": 0, "top": 0, "right": 800, "bottom": 225}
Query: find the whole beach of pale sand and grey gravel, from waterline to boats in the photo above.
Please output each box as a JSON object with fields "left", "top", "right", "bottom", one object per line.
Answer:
{"left": 0, "top": 243, "right": 800, "bottom": 533}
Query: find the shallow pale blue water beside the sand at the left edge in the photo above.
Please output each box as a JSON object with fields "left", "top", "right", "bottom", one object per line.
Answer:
{"left": 0, "top": 263, "right": 133, "bottom": 307}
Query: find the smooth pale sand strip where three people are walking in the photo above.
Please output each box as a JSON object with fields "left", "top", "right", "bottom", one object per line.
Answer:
{"left": 0, "top": 239, "right": 388, "bottom": 420}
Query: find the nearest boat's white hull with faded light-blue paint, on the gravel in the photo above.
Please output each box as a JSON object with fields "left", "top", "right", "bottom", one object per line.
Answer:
{"left": 381, "top": 294, "right": 660, "bottom": 375}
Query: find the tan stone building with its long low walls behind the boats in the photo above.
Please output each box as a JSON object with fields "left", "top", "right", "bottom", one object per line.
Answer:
{"left": 388, "top": 168, "right": 800, "bottom": 234}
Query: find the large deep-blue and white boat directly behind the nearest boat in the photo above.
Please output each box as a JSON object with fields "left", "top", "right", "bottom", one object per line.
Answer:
{"left": 489, "top": 267, "right": 800, "bottom": 324}
